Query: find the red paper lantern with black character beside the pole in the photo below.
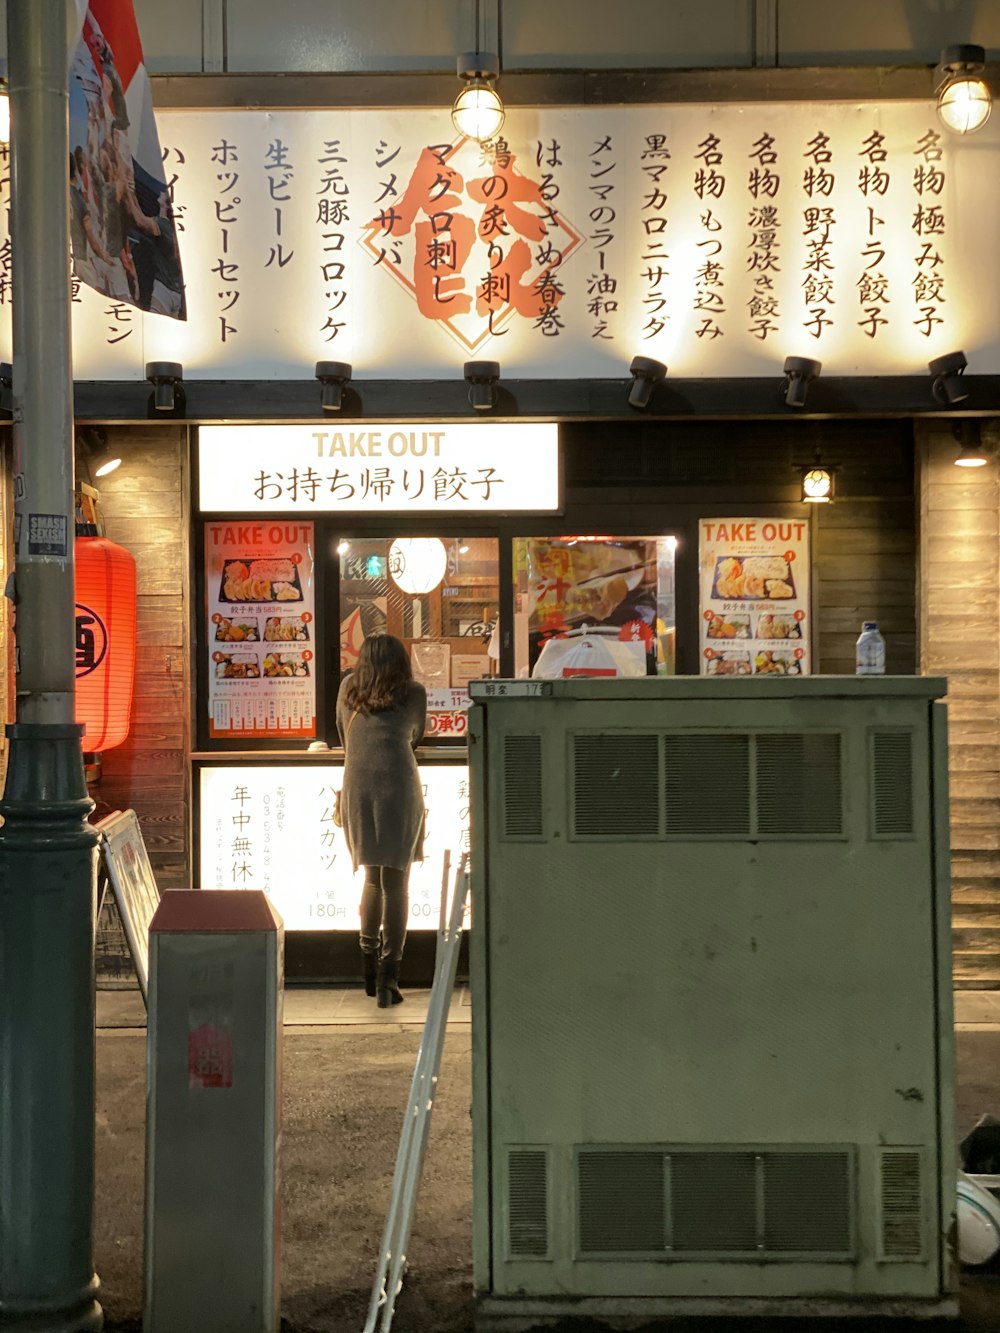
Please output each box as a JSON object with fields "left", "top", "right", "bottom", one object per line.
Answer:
{"left": 76, "top": 537, "right": 136, "bottom": 754}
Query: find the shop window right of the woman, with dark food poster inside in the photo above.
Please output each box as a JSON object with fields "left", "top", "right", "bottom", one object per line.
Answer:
{"left": 513, "top": 536, "right": 677, "bottom": 677}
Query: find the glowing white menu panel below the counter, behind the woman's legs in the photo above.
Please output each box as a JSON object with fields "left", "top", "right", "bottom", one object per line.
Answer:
{"left": 199, "top": 764, "right": 469, "bottom": 930}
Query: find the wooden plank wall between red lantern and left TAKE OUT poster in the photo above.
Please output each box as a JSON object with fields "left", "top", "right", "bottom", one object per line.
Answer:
{"left": 91, "top": 424, "right": 192, "bottom": 890}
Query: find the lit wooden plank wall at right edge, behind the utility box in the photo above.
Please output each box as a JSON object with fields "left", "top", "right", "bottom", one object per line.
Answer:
{"left": 917, "top": 423, "right": 1000, "bottom": 989}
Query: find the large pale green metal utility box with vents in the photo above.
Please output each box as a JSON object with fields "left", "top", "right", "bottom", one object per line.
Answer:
{"left": 469, "top": 676, "right": 957, "bottom": 1330}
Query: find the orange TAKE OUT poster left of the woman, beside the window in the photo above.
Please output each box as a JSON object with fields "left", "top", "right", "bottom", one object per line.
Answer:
{"left": 205, "top": 521, "right": 316, "bottom": 738}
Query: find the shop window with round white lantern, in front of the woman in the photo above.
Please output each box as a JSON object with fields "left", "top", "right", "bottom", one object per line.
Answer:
{"left": 339, "top": 537, "right": 500, "bottom": 706}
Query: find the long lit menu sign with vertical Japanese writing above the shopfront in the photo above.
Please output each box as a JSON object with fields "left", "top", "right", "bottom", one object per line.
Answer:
{"left": 0, "top": 101, "right": 1000, "bottom": 378}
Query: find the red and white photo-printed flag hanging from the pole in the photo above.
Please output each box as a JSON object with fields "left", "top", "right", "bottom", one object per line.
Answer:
{"left": 69, "top": 0, "right": 187, "bottom": 318}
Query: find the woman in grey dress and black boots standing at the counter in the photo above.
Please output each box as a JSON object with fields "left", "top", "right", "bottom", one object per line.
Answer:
{"left": 337, "top": 635, "right": 427, "bottom": 1009}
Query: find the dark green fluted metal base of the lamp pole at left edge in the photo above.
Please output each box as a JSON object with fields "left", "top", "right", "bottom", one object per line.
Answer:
{"left": 0, "top": 722, "right": 104, "bottom": 1333}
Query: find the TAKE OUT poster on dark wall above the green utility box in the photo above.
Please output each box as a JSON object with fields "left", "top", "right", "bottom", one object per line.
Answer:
{"left": 699, "top": 519, "right": 811, "bottom": 676}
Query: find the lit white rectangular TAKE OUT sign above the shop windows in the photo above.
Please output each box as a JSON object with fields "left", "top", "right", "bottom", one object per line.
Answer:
{"left": 199, "top": 421, "right": 559, "bottom": 516}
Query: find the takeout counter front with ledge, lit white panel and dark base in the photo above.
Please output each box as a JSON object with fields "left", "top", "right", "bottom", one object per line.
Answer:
{"left": 192, "top": 745, "right": 469, "bottom": 984}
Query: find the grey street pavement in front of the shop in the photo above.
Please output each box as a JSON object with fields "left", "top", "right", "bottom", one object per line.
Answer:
{"left": 95, "top": 988, "right": 1000, "bottom": 1333}
